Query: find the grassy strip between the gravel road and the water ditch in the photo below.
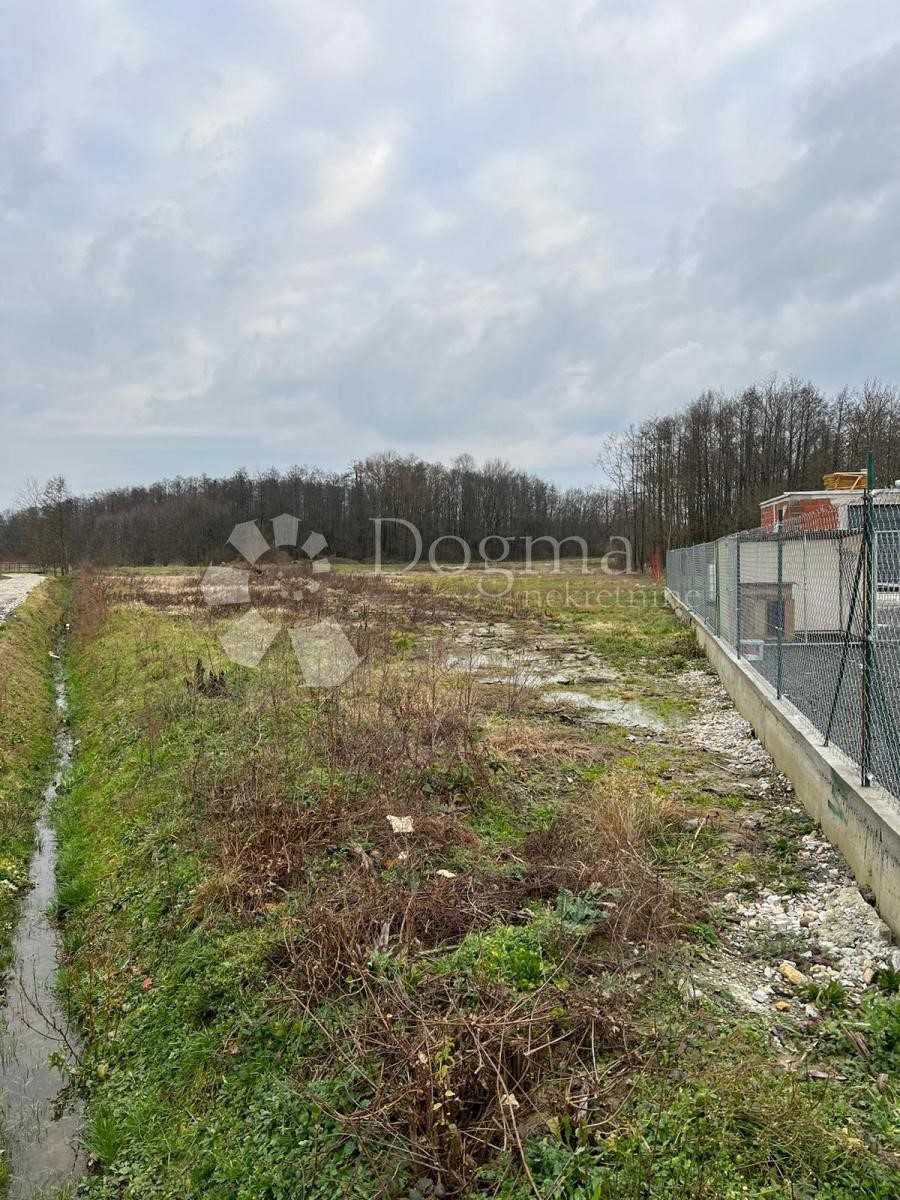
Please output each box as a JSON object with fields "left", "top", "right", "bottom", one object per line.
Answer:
{"left": 0, "top": 582, "right": 66, "bottom": 1194}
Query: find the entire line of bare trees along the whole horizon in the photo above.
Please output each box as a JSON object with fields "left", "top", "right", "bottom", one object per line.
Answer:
{"left": 7, "top": 378, "right": 900, "bottom": 569}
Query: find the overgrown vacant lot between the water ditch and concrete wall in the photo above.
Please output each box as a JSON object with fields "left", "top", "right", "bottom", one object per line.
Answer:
{"left": 47, "top": 568, "right": 900, "bottom": 1200}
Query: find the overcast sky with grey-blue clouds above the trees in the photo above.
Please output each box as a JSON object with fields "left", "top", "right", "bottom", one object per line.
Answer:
{"left": 0, "top": 0, "right": 900, "bottom": 506}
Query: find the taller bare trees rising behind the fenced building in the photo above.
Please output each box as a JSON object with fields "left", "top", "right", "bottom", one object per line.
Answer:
{"left": 601, "top": 378, "right": 900, "bottom": 562}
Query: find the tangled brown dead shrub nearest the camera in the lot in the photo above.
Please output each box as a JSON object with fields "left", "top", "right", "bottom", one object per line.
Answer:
{"left": 290, "top": 977, "right": 626, "bottom": 1196}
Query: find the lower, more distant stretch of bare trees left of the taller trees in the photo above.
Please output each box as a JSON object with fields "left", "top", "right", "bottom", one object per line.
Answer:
{"left": 0, "top": 454, "right": 614, "bottom": 566}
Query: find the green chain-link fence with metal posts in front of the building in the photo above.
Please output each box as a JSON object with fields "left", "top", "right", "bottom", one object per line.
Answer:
{"left": 666, "top": 492, "right": 900, "bottom": 803}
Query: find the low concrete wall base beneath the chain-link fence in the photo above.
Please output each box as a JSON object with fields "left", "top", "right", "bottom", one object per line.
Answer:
{"left": 666, "top": 590, "right": 900, "bottom": 936}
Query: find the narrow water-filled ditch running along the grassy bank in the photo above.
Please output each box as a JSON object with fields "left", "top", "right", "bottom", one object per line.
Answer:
{"left": 0, "top": 664, "right": 83, "bottom": 1200}
